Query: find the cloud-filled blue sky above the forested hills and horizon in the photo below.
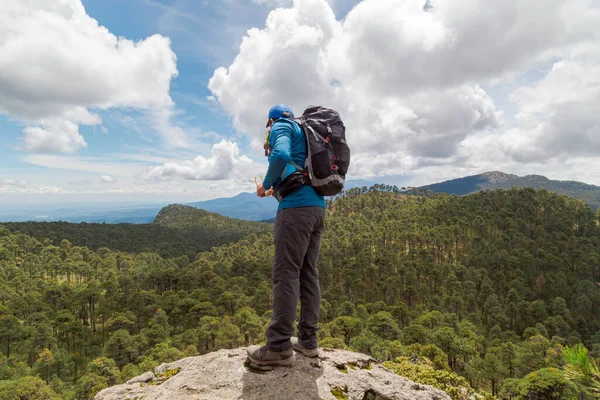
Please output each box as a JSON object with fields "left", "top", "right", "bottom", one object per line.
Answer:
{"left": 0, "top": 0, "right": 600, "bottom": 206}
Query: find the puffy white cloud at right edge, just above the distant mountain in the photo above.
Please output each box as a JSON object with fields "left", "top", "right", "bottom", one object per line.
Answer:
{"left": 501, "top": 46, "right": 600, "bottom": 163}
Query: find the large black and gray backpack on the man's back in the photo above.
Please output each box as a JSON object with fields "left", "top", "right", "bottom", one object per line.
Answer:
{"left": 278, "top": 106, "right": 350, "bottom": 200}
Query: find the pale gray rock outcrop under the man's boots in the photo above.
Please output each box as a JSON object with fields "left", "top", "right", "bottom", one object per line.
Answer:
{"left": 95, "top": 348, "right": 450, "bottom": 400}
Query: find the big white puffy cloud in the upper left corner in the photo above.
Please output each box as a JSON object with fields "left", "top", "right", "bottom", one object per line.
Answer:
{"left": 0, "top": 0, "right": 183, "bottom": 153}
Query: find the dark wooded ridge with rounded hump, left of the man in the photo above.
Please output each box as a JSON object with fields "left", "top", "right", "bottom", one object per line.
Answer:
{"left": 0, "top": 205, "right": 271, "bottom": 258}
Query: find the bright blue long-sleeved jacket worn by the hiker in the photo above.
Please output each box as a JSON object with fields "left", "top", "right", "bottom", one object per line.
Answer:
{"left": 263, "top": 118, "right": 325, "bottom": 210}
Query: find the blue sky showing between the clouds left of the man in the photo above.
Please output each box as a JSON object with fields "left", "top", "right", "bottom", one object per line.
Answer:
{"left": 0, "top": 0, "right": 366, "bottom": 205}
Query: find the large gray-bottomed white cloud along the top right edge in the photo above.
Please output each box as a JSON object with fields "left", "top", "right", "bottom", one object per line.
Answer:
{"left": 330, "top": 0, "right": 598, "bottom": 94}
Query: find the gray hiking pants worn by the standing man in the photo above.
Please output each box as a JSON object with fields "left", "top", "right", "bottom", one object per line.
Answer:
{"left": 267, "top": 207, "right": 325, "bottom": 351}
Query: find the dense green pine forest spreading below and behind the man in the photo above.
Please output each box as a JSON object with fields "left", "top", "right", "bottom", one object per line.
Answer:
{"left": 0, "top": 185, "right": 600, "bottom": 400}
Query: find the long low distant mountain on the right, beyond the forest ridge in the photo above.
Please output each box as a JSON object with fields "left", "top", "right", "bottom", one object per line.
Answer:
{"left": 423, "top": 171, "right": 600, "bottom": 210}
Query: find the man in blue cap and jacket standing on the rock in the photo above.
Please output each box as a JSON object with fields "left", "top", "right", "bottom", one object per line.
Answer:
{"left": 248, "top": 104, "right": 325, "bottom": 365}
